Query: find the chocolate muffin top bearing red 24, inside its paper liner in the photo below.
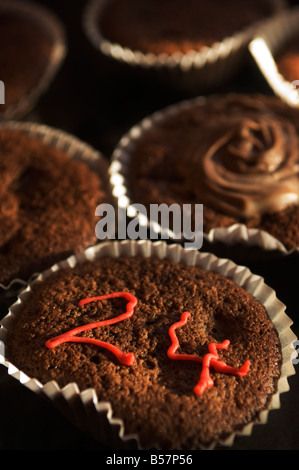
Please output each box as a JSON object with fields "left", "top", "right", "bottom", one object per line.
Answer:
{"left": 5, "top": 255, "right": 282, "bottom": 449}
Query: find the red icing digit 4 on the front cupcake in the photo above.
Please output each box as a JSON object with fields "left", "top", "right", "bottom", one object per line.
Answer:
{"left": 167, "top": 312, "right": 250, "bottom": 395}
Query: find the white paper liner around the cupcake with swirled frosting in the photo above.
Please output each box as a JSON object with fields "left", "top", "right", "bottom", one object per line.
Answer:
{"left": 109, "top": 97, "right": 299, "bottom": 255}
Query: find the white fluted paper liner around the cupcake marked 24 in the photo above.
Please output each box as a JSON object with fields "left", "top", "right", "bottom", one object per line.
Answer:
{"left": 0, "top": 240, "right": 296, "bottom": 450}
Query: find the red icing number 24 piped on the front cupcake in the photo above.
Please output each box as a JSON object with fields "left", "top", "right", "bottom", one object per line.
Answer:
{"left": 46, "top": 292, "right": 250, "bottom": 395}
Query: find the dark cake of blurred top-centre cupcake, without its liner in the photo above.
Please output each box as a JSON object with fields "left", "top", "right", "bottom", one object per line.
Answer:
{"left": 99, "top": 0, "right": 283, "bottom": 54}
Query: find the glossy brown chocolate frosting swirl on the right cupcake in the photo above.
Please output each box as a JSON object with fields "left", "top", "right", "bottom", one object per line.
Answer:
{"left": 179, "top": 100, "right": 299, "bottom": 219}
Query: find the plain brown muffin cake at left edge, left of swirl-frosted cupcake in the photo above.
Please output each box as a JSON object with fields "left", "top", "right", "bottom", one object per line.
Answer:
{"left": 0, "top": 128, "right": 109, "bottom": 285}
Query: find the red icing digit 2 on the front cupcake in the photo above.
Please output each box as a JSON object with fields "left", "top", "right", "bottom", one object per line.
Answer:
{"left": 46, "top": 292, "right": 137, "bottom": 366}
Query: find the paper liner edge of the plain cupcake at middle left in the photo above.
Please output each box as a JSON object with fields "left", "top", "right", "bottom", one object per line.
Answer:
{"left": 0, "top": 121, "right": 110, "bottom": 296}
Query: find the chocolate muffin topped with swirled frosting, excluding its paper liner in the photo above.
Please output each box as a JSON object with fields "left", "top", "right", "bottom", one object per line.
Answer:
{"left": 124, "top": 95, "right": 299, "bottom": 249}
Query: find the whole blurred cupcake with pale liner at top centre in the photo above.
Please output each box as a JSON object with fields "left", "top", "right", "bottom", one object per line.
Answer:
{"left": 84, "top": 0, "right": 285, "bottom": 91}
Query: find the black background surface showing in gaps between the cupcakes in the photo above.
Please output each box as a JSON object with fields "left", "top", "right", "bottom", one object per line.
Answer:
{"left": 0, "top": 0, "right": 299, "bottom": 450}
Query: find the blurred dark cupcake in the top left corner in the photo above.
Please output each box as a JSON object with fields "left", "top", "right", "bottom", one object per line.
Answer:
{"left": 0, "top": 1, "right": 66, "bottom": 119}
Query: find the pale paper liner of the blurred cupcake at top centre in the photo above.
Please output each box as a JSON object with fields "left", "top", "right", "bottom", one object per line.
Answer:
{"left": 83, "top": 0, "right": 284, "bottom": 92}
